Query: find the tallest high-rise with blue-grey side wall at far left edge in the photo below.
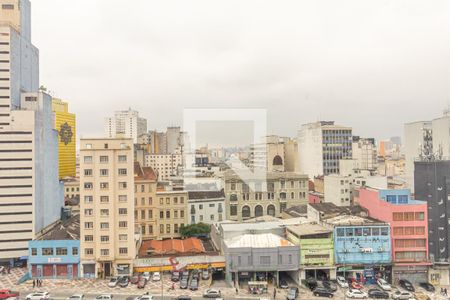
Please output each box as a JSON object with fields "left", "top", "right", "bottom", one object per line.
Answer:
{"left": 0, "top": 0, "right": 64, "bottom": 263}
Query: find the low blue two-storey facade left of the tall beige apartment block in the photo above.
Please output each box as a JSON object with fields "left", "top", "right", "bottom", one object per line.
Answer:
{"left": 28, "top": 240, "right": 80, "bottom": 279}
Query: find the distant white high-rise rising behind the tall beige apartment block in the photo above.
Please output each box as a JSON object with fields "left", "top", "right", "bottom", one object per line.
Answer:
{"left": 105, "top": 108, "right": 147, "bottom": 144}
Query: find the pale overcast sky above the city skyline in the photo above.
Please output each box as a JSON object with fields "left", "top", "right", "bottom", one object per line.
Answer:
{"left": 32, "top": 0, "right": 450, "bottom": 145}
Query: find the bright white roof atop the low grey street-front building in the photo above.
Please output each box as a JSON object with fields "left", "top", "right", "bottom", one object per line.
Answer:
{"left": 225, "top": 233, "right": 295, "bottom": 248}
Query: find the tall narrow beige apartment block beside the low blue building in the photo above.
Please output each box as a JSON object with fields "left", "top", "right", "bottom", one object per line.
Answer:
{"left": 80, "top": 138, "right": 136, "bottom": 278}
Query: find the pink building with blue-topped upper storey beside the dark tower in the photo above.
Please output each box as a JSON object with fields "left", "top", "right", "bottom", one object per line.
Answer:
{"left": 354, "top": 188, "right": 431, "bottom": 283}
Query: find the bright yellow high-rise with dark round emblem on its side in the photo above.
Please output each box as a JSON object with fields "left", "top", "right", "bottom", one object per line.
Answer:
{"left": 52, "top": 98, "right": 77, "bottom": 179}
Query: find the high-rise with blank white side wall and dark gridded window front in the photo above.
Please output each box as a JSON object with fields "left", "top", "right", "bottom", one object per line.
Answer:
{"left": 298, "top": 121, "right": 352, "bottom": 178}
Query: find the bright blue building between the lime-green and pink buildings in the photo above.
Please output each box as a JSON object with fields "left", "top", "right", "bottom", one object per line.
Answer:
{"left": 334, "top": 224, "right": 392, "bottom": 283}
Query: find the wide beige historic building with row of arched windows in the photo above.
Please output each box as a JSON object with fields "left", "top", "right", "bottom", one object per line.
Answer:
{"left": 223, "top": 170, "right": 308, "bottom": 221}
